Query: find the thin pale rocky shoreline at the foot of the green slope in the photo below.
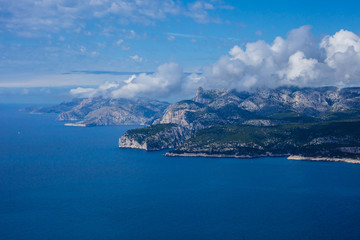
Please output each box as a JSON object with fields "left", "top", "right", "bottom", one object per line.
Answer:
{"left": 165, "top": 153, "right": 360, "bottom": 164}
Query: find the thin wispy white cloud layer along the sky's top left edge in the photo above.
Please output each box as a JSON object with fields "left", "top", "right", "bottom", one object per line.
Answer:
{"left": 0, "top": 0, "right": 230, "bottom": 37}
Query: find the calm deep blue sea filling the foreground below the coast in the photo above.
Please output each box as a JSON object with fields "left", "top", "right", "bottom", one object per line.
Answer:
{"left": 0, "top": 105, "right": 360, "bottom": 240}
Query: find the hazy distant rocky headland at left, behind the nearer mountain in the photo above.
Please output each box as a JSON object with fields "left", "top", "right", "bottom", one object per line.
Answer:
{"left": 32, "top": 97, "right": 169, "bottom": 126}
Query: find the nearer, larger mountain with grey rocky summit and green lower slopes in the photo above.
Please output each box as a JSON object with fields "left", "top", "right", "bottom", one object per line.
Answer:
{"left": 119, "top": 87, "right": 360, "bottom": 161}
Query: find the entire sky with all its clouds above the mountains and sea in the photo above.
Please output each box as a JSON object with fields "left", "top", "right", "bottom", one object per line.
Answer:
{"left": 0, "top": 0, "right": 360, "bottom": 102}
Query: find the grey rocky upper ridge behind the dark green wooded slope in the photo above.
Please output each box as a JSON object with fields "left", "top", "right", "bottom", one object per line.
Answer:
{"left": 148, "top": 87, "right": 360, "bottom": 131}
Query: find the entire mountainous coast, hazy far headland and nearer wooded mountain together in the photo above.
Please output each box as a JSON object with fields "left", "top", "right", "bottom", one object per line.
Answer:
{"left": 31, "top": 87, "right": 360, "bottom": 159}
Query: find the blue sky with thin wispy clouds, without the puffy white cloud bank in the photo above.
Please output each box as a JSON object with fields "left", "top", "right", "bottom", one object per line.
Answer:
{"left": 0, "top": 0, "right": 360, "bottom": 101}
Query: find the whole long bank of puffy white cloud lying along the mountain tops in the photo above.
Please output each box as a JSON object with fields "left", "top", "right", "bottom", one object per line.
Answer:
{"left": 71, "top": 26, "right": 360, "bottom": 98}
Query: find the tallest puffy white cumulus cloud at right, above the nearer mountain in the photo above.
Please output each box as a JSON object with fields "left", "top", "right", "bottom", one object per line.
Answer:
{"left": 199, "top": 26, "right": 360, "bottom": 90}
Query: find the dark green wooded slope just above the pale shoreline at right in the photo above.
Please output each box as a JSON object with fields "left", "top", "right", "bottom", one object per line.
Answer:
{"left": 172, "top": 120, "right": 360, "bottom": 158}
